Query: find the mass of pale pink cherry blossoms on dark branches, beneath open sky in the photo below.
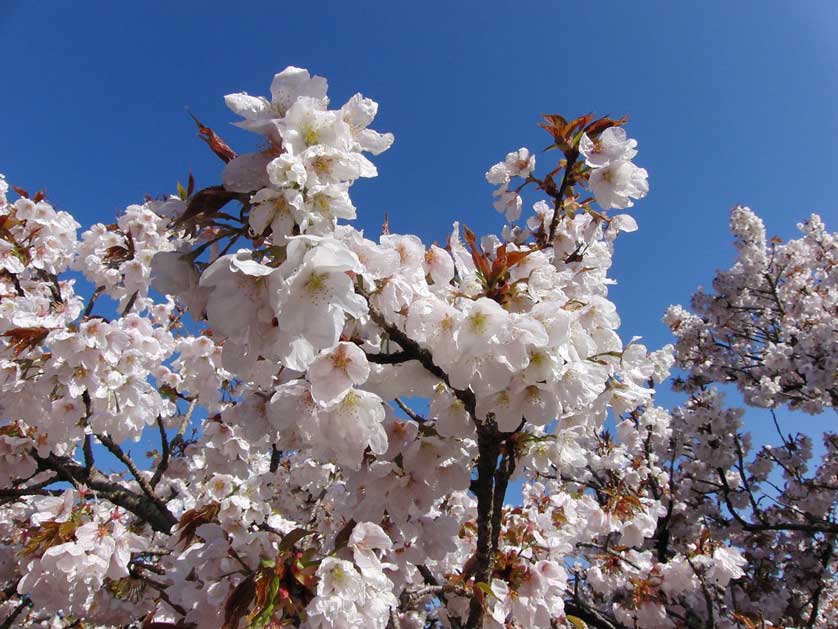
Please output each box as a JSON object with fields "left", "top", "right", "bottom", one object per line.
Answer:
{"left": 0, "top": 67, "right": 838, "bottom": 629}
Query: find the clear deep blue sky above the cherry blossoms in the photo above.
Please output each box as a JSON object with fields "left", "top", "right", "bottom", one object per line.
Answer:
{"left": 0, "top": 0, "right": 838, "bottom": 446}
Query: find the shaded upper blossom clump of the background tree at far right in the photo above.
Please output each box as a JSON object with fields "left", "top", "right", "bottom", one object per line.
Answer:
{"left": 666, "top": 206, "right": 838, "bottom": 413}
